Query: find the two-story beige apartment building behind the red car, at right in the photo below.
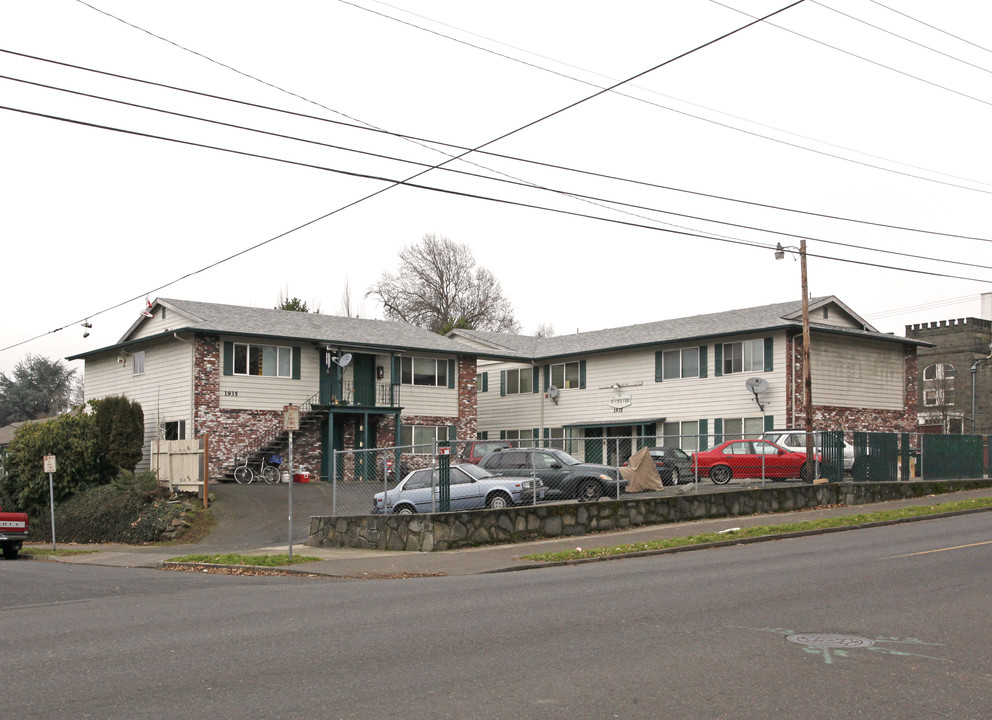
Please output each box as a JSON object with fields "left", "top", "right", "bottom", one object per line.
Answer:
{"left": 449, "top": 296, "right": 927, "bottom": 463}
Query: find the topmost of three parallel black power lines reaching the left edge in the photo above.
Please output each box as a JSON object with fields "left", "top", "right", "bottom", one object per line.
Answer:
{"left": 0, "top": 47, "right": 992, "bottom": 242}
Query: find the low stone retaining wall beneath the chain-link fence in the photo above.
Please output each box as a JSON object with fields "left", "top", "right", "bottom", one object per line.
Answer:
{"left": 307, "top": 480, "right": 992, "bottom": 552}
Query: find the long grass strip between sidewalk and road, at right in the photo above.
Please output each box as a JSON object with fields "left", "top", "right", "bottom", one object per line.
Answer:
{"left": 523, "top": 498, "right": 992, "bottom": 562}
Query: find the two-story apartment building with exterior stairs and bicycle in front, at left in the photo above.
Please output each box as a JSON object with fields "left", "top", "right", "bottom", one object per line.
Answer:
{"left": 70, "top": 298, "right": 488, "bottom": 479}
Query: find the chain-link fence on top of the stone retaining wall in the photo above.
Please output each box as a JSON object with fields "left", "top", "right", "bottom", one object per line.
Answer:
{"left": 331, "top": 430, "right": 989, "bottom": 515}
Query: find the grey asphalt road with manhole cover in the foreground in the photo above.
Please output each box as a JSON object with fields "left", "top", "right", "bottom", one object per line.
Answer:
{"left": 0, "top": 513, "right": 992, "bottom": 720}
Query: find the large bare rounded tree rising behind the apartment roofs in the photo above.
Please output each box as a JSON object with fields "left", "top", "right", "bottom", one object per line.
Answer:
{"left": 366, "top": 234, "right": 520, "bottom": 335}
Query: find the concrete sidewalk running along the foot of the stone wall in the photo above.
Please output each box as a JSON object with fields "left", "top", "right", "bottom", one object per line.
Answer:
{"left": 26, "top": 488, "right": 992, "bottom": 579}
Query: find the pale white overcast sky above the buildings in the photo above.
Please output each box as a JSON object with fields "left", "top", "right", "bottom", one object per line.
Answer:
{"left": 0, "top": 0, "right": 992, "bottom": 372}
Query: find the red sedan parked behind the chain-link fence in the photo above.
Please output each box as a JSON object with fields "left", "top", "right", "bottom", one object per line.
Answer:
{"left": 692, "top": 440, "right": 821, "bottom": 485}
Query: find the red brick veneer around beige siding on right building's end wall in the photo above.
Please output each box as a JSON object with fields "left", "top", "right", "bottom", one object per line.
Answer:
{"left": 783, "top": 333, "right": 919, "bottom": 432}
